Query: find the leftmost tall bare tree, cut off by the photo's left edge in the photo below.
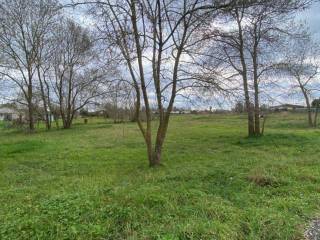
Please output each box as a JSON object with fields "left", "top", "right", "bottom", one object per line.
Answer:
{"left": 0, "top": 0, "right": 59, "bottom": 131}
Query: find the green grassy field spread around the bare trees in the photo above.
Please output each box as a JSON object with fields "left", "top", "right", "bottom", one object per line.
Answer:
{"left": 0, "top": 114, "right": 320, "bottom": 240}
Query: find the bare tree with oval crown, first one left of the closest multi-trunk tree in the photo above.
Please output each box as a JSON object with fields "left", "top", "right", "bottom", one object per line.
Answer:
{"left": 52, "top": 19, "right": 109, "bottom": 128}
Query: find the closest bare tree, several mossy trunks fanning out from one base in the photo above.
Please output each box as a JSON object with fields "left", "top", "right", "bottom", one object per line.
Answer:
{"left": 75, "top": 0, "right": 241, "bottom": 166}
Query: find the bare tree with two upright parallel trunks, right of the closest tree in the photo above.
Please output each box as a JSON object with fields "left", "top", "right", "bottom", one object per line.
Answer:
{"left": 196, "top": 0, "right": 309, "bottom": 136}
